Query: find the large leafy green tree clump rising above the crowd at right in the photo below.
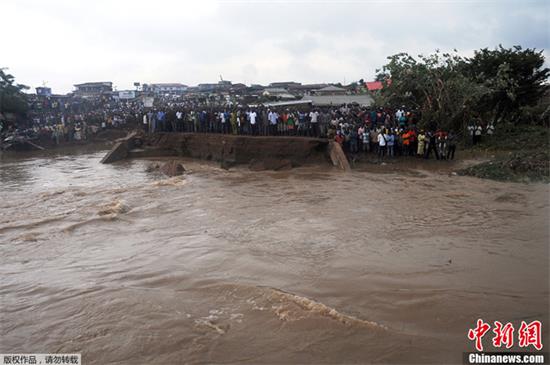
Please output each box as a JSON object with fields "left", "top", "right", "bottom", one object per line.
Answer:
{"left": 375, "top": 46, "right": 550, "bottom": 130}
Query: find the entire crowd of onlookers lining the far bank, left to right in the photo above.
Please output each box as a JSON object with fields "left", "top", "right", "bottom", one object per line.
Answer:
{"left": 0, "top": 94, "right": 494, "bottom": 160}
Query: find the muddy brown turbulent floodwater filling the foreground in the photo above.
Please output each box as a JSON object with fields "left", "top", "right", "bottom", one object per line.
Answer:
{"left": 0, "top": 146, "right": 550, "bottom": 364}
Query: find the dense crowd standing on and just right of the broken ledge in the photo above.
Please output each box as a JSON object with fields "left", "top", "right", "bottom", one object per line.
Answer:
{"left": 138, "top": 105, "right": 474, "bottom": 160}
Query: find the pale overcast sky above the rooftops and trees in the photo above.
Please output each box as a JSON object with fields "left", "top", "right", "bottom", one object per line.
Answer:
{"left": 0, "top": 0, "right": 550, "bottom": 93}
